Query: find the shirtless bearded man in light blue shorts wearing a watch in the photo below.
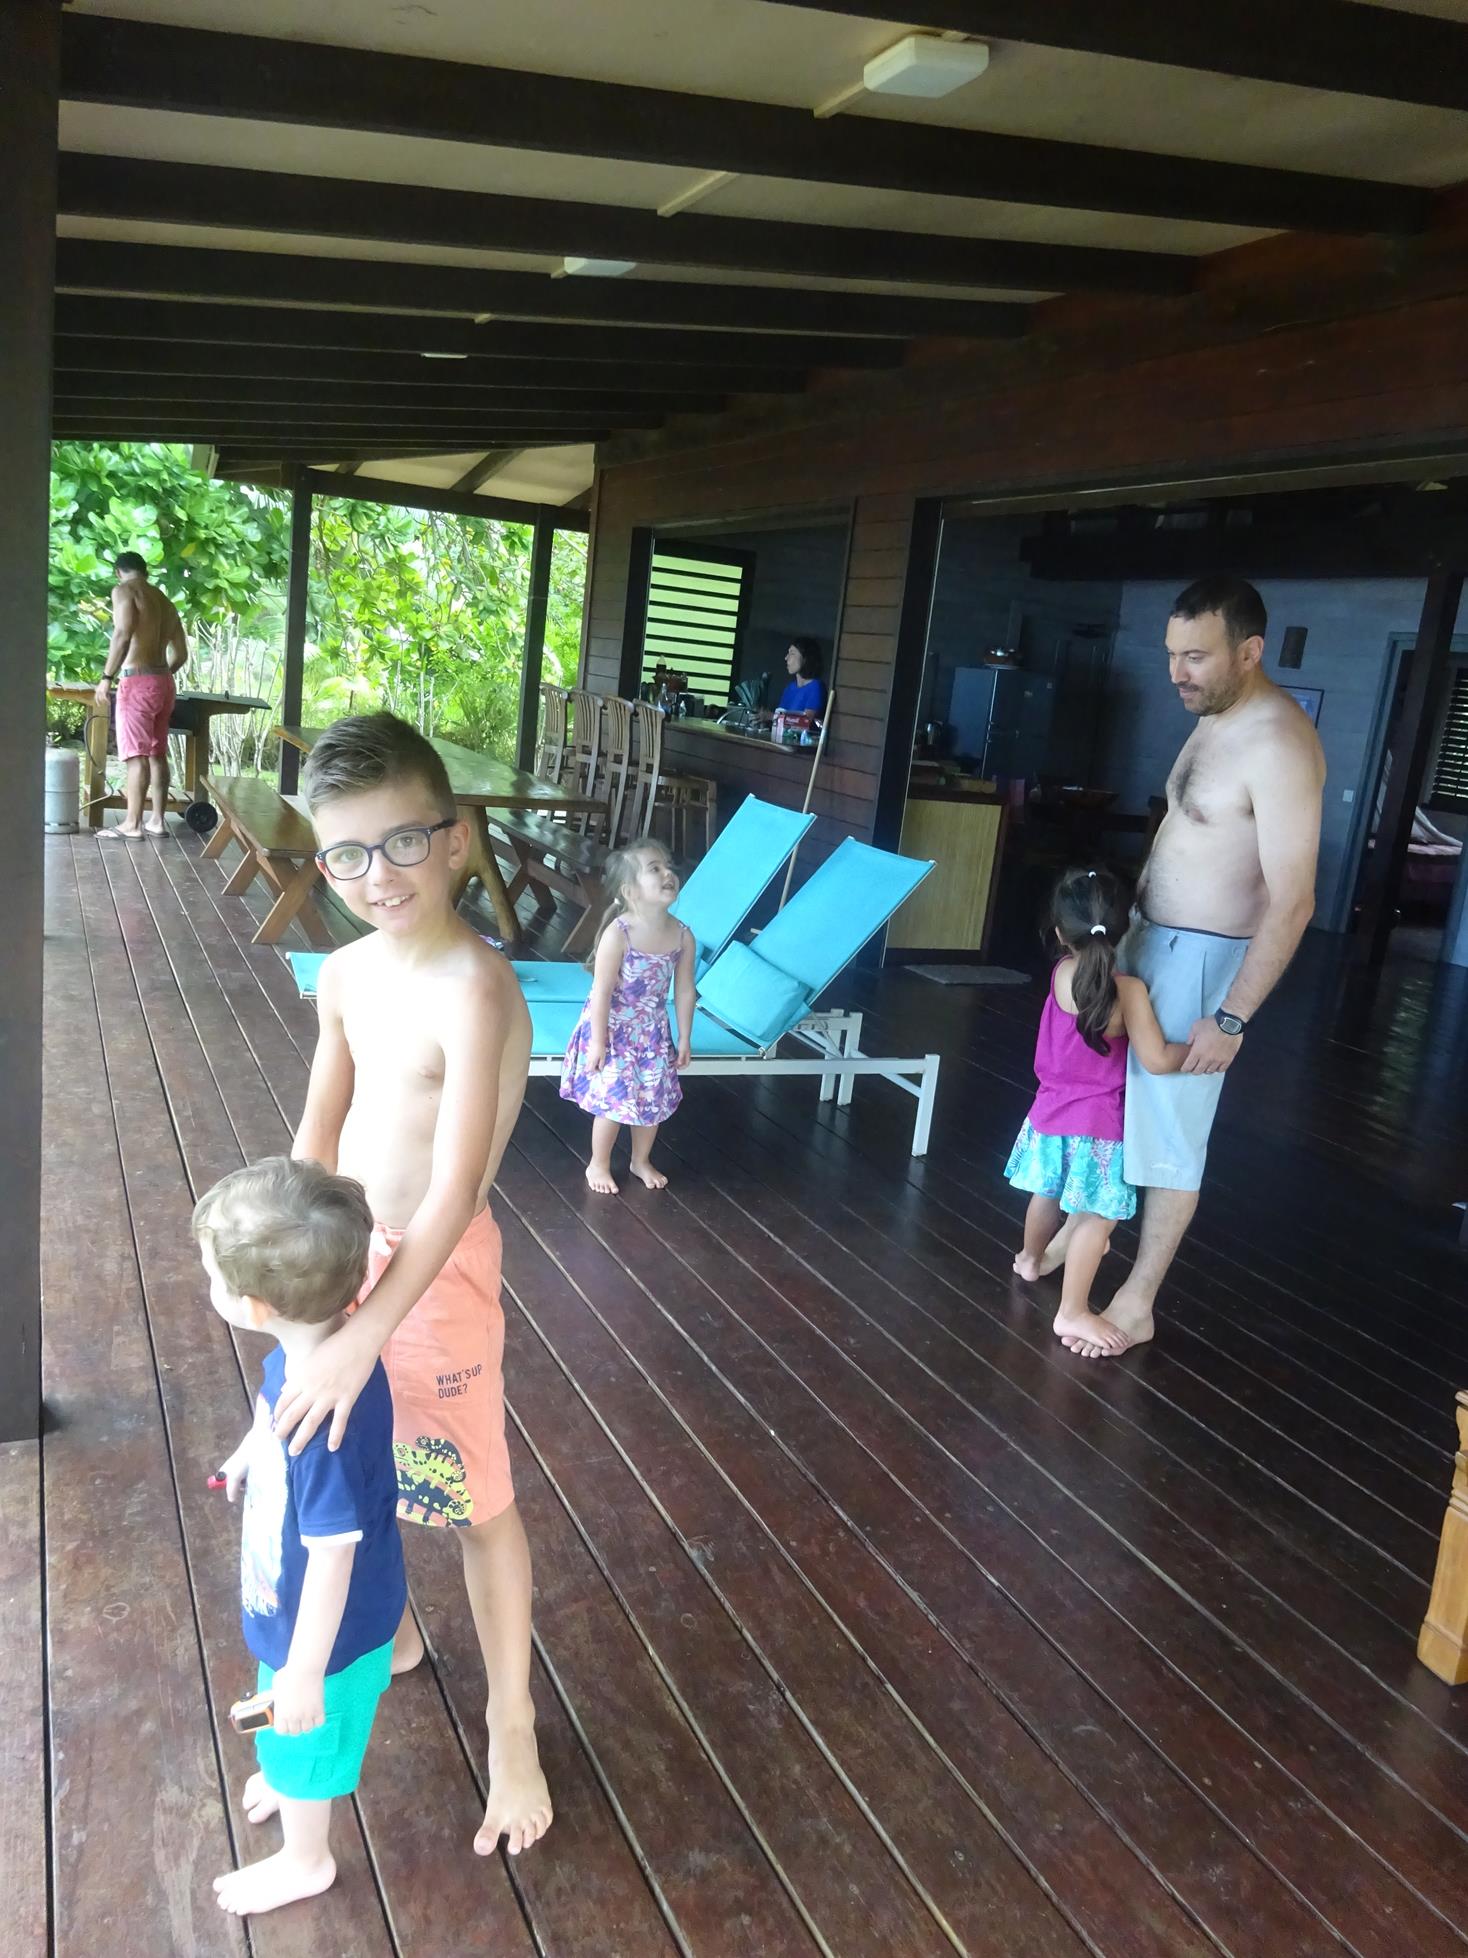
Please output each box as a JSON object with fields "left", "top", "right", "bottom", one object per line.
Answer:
{"left": 1043, "top": 574, "right": 1325, "bottom": 1359}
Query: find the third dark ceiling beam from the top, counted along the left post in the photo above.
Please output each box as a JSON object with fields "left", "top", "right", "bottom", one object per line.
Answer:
{"left": 57, "top": 237, "right": 1030, "bottom": 339}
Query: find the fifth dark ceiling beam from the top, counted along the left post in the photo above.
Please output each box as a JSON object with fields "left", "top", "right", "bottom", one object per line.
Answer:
{"left": 55, "top": 333, "right": 804, "bottom": 401}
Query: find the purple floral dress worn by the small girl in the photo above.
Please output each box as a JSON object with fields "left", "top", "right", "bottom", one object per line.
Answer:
{"left": 560, "top": 918, "right": 687, "bottom": 1128}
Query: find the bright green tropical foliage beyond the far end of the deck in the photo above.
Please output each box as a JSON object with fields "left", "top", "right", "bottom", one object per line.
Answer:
{"left": 49, "top": 443, "right": 585, "bottom": 768}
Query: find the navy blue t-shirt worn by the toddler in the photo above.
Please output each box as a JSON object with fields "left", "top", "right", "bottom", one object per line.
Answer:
{"left": 239, "top": 1347, "right": 407, "bottom": 1672}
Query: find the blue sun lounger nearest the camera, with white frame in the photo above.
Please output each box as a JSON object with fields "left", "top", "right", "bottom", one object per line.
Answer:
{"left": 527, "top": 836, "right": 938, "bottom": 1155}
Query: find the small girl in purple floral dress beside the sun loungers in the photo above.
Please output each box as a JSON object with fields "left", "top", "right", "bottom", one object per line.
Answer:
{"left": 560, "top": 836, "right": 693, "bottom": 1196}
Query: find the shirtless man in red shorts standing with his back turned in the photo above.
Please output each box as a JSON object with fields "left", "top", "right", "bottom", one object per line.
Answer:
{"left": 96, "top": 550, "right": 188, "bottom": 838}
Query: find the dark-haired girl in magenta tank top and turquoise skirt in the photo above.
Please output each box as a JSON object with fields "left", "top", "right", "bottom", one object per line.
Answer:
{"left": 1004, "top": 869, "right": 1188, "bottom": 1357}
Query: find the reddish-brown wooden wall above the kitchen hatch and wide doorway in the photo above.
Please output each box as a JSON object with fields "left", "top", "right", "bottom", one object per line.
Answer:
{"left": 587, "top": 212, "right": 1468, "bottom": 873}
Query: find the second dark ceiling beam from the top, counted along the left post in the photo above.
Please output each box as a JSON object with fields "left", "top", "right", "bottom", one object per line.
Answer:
{"left": 57, "top": 153, "right": 1194, "bottom": 292}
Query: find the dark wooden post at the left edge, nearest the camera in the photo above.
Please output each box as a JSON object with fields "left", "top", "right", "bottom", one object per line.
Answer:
{"left": 0, "top": 0, "right": 59, "bottom": 1441}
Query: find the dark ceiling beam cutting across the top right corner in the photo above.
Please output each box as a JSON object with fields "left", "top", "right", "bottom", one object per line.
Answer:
{"left": 785, "top": 0, "right": 1468, "bottom": 110}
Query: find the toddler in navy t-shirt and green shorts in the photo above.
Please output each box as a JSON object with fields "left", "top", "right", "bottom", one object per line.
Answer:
{"left": 194, "top": 1155, "right": 407, "bottom": 1917}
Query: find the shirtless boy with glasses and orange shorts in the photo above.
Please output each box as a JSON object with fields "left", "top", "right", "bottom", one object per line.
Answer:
{"left": 270, "top": 715, "right": 552, "bottom": 1856}
